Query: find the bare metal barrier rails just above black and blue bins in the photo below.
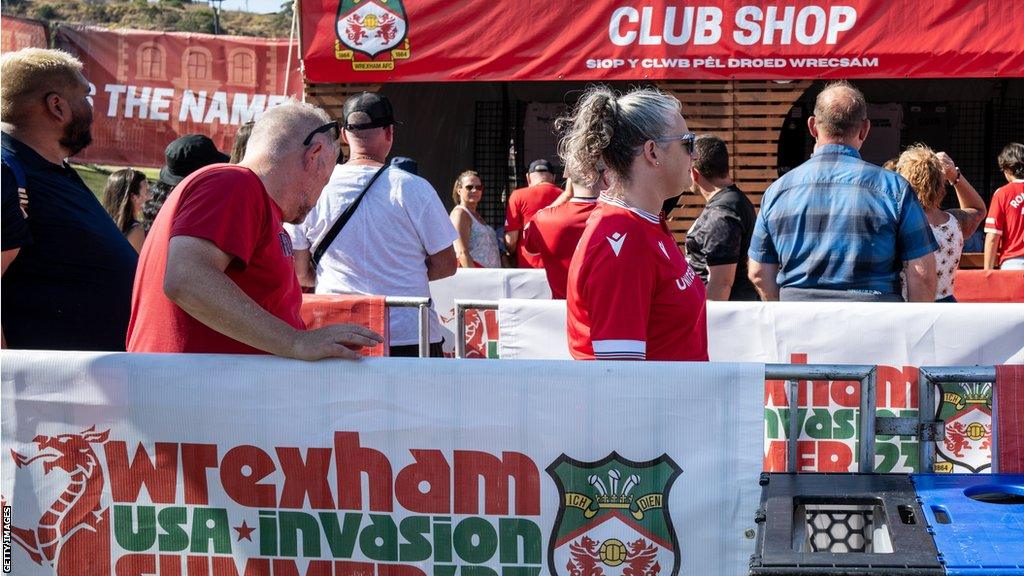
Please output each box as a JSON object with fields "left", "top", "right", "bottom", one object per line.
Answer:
{"left": 765, "top": 364, "right": 999, "bottom": 474}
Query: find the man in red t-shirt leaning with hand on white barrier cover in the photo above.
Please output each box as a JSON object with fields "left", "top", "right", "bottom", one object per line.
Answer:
{"left": 128, "top": 102, "right": 382, "bottom": 360}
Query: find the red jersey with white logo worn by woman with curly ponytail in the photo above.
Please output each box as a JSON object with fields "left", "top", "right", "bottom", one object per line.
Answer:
{"left": 566, "top": 197, "right": 708, "bottom": 361}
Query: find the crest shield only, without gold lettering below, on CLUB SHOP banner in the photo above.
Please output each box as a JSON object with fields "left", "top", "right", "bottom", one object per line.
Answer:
{"left": 336, "top": 0, "right": 408, "bottom": 57}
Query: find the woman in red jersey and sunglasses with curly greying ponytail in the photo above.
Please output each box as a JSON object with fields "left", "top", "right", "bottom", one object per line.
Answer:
{"left": 559, "top": 86, "right": 708, "bottom": 361}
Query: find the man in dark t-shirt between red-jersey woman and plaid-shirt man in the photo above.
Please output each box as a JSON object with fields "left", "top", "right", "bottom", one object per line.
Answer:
{"left": 686, "top": 136, "right": 759, "bottom": 300}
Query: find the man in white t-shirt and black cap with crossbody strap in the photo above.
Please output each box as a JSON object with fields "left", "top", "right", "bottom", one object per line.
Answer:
{"left": 288, "top": 92, "right": 458, "bottom": 356}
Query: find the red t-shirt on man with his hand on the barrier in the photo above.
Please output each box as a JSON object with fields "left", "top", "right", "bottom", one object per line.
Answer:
{"left": 128, "top": 164, "right": 305, "bottom": 354}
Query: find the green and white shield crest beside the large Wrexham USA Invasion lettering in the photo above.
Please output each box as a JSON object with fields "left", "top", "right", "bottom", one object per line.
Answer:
{"left": 547, "top": 452, "right": 682, "bottom": 576}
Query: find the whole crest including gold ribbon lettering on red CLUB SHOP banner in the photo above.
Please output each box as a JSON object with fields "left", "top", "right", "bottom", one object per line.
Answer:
{"left": 335, "top": 0, "right": 410, "bottom": 72}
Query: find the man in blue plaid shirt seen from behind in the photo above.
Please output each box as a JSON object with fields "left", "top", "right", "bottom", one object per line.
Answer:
{"left": 748, "top": 82, "right": 938, "bottom": 302}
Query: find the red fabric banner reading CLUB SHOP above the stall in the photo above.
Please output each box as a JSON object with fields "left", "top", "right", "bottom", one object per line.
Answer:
{"left": 301, "top": 0, "right": 1024, "bottom": 82}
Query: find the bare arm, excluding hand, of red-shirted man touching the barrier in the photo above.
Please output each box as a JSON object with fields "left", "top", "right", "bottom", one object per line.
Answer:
{"left": 164, "top": 261, "right": 297, "bottom": 356}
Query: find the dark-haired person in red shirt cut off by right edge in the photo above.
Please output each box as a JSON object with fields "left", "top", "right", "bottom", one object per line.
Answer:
{"left": 985, "top": 142, "right": 1024, "bottom": 270}
